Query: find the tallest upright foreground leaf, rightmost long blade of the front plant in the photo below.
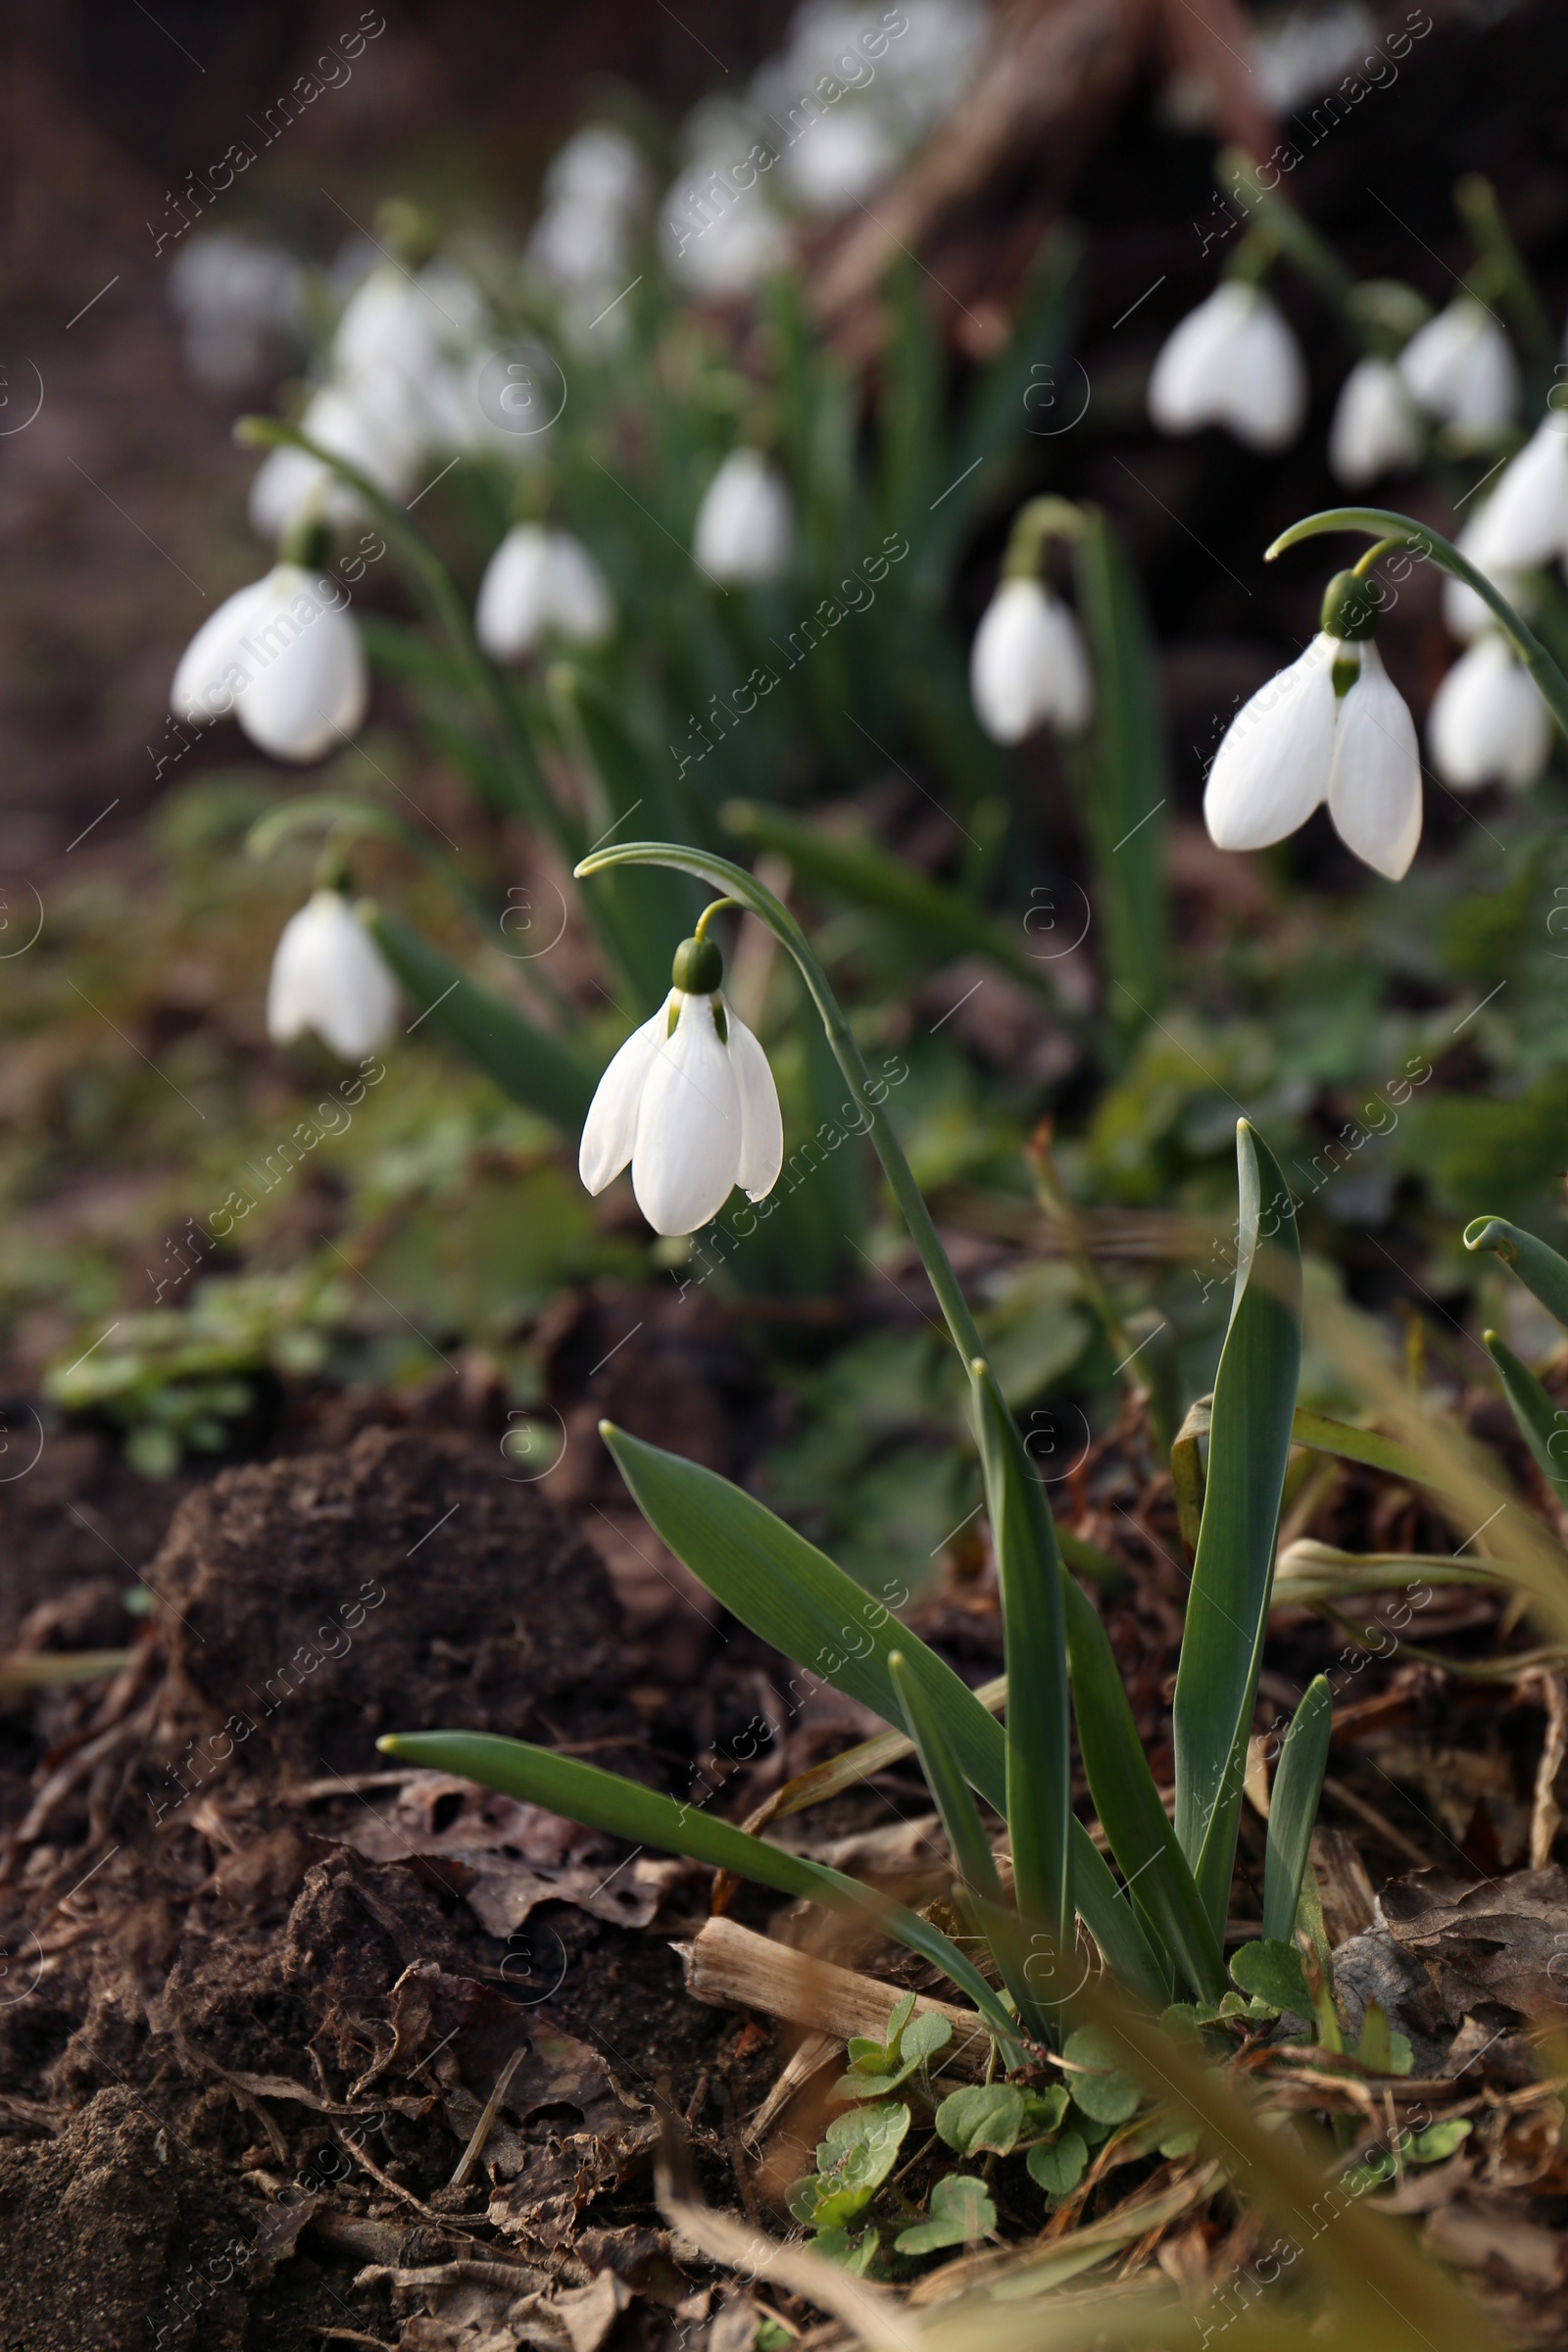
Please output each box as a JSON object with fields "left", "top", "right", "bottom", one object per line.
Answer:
{"left": 1173, "top": 1119, "right": 1300, "bottom": 1936}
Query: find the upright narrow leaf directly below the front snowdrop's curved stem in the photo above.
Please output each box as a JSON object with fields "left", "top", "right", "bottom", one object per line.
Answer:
{"left": 968, "top": 1357, "right": 1072, "bottom": 1945}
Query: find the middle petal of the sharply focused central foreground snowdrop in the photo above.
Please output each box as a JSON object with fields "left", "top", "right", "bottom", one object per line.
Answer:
{"left": 632, "top": 998, "right": 741, "bottom": 1233}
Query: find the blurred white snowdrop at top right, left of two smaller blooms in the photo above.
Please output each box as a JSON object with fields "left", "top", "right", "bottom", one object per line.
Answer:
{"left": 1150, "top": 277, "right": 1307, "bottom": 449}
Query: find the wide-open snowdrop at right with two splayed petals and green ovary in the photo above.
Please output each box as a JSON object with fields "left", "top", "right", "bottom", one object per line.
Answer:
{"left": 1203, "top": 571, "right": 1420, "bottom": 882}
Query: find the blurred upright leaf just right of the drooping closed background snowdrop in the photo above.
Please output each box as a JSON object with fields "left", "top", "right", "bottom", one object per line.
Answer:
{"left": 1065, "top": 506, "right": 1171, "bottom": 1028}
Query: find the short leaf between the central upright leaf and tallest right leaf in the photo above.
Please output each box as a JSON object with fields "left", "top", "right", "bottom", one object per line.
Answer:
{"left": 1062, "top": 1578, "right": 1225, "bottom": 2001}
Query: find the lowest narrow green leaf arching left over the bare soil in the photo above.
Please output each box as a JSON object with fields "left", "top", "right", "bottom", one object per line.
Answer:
{"left": 376, "top": 1731, "right": 1022, "bottom": 2056}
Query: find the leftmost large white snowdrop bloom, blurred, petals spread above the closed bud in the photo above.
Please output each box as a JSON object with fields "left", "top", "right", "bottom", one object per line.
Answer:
{"left": 170, "top": 563, "right": 369, "bottom": 762}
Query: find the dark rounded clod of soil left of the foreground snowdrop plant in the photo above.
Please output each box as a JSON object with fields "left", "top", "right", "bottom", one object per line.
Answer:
{"left": 148, "top": 1428, "right": 623, "bottom": 1768}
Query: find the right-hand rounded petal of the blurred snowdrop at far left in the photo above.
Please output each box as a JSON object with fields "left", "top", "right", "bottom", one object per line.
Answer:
{"left": 237, "top": 564, "right": 369, "bottom": 760}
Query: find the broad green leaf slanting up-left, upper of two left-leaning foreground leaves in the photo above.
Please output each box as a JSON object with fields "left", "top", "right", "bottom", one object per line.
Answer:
{"left": 602, "top": 1423, "right": 1166, "bottom": 2001}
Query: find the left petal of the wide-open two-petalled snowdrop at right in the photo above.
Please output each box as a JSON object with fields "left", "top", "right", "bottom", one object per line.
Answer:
{"left": 1203, "top": 633, "right": 1345, "bottom": 849}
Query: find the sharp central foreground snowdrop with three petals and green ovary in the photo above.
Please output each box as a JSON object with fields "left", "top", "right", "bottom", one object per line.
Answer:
{"left": 578, "top": 929, "right": 783, "bottom": 1235}
